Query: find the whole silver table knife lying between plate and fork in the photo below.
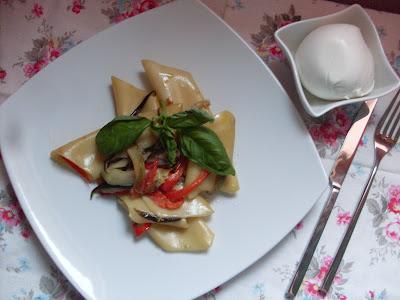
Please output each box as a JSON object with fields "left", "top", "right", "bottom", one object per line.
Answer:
{"left": 285, "top": 99, "right": 377, "bottom": 299}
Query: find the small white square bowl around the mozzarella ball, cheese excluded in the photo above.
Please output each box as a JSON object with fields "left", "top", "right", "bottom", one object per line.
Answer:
{"left": 275, "top": 4, "right": 400, "bottom": 117}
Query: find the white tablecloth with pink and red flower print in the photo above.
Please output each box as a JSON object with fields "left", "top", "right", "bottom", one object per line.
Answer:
{"left": 0, "top": 0, "right": 400, "bottom": 300}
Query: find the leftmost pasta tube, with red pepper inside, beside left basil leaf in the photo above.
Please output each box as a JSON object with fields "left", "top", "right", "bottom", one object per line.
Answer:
{"left": 50, "top": 131, "right": 104, "bottom": 181}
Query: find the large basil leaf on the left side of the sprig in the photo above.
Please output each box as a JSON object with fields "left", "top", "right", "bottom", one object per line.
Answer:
{"left": 96, "top": 116, "right": 151, "bottom": 156}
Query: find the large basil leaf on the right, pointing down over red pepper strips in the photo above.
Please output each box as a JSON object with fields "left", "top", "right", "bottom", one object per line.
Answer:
{"left": 179, "top": 127, "right": 235, "bottom": 175}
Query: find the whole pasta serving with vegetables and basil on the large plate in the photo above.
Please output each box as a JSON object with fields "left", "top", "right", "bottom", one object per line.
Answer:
{"left": 51, "top": 60, "right": 239, "bottom": 252}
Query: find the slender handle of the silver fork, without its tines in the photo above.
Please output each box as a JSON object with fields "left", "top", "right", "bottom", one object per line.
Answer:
{"left": 319, "top": 153, "right": 383, "bottom": 296}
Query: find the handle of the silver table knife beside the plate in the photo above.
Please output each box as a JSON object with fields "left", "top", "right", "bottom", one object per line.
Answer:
{"left": 285, "top": 186, "right": 340, "bottom": 299}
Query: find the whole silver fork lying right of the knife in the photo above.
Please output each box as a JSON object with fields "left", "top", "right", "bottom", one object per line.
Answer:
{"left": 319, "top": 89, "right": 400, "bottom": 296}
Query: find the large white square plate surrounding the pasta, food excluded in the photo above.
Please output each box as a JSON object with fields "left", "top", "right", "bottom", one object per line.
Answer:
{"left": 0, "top": 1, "right": 327, "bottom": 299}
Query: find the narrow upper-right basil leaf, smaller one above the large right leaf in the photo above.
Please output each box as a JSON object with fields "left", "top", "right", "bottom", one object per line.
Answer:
{"left": 166, "top": 109, "right": 214, "bottom": 129}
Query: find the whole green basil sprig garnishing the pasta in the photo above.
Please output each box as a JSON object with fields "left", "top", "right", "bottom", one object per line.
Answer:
{"left": 96, "top": 109, "right": 235, "bottom": 175}
